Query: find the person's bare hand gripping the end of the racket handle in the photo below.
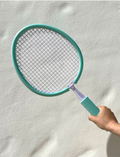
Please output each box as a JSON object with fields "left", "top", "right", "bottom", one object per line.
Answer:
{"left": 88, "top": 106, "right": 118, "bottom": 131}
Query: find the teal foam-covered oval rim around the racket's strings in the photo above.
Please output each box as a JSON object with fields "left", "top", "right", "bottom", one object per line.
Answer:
{"left": 11, "top": 24, "right": 83, "bottom": 96}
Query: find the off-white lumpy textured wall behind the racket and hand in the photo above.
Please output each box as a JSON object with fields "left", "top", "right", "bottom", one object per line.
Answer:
{"left": 0, "top": 1, "right": 120, "bottom": 157}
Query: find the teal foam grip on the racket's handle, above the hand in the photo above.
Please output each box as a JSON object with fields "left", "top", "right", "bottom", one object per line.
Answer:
{"left": 81, "top": 97, "right": 100, "bottom": 116}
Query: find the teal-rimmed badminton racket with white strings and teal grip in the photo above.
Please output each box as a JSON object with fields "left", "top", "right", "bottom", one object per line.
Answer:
{"left": 11, "top": 24, "right": 99, "bottom": 116}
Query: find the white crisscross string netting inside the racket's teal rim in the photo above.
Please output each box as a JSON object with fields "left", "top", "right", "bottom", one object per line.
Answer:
{"left": 15, "top": 28, "right": 79, "bottom": 93}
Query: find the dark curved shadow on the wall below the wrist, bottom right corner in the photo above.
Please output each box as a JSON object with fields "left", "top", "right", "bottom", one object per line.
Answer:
{"left": 107, "top": 134, "right": 120, "bottom": 157}
